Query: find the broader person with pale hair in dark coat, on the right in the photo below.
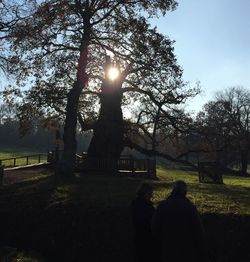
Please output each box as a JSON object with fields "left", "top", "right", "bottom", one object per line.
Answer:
{"left": 152, "top": 180, "right": 207, "bottom": 262}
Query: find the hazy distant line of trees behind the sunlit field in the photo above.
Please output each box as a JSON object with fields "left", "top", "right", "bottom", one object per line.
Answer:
{"left": 0, "top": 87, "right": 250, "bottom": 176}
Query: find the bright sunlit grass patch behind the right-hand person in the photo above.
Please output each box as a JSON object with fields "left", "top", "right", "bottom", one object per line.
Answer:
{"left": 154, "top": 169, "right": 250, "bottom": 215}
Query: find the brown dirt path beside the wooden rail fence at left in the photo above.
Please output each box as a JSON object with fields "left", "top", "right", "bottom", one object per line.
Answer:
{"left": 3, "top": 165, "right": 52, "bottom": 185}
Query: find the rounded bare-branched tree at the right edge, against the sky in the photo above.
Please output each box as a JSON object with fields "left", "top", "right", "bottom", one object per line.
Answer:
{"left": 197, "top": 87, "right": 250, "bottom": 175}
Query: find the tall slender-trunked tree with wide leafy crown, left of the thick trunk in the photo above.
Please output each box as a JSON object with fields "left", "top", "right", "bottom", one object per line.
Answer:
{"left": 0, "top": 0, "right": 196, "bottom": 174}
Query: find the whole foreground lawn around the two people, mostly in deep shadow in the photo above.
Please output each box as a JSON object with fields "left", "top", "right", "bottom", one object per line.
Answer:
{"left": 0, "top": 167, "right": 250, "bottom": 262}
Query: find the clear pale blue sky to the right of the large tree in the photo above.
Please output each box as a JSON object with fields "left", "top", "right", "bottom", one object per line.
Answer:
{"left": 150, "top": 0, "right": 250, "bottom": 111}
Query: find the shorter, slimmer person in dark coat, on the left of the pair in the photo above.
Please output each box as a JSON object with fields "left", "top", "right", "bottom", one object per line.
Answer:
{"left": 131, "top": 183, "right": 156, "bottom": 262}
